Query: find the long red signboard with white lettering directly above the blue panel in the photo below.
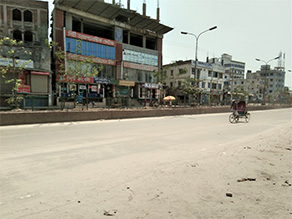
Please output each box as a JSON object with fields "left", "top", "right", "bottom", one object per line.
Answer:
{"left": 66, "top": 30, "right": 116, "bottom": 47}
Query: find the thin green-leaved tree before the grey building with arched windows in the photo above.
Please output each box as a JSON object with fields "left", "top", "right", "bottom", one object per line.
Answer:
{"left": 0, "top": 37, "right": 31, "bottom": 108}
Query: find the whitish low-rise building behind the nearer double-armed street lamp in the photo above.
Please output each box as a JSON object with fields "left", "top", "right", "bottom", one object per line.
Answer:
{"left": 164, "top": 58, "right": 224, "bottom": 104}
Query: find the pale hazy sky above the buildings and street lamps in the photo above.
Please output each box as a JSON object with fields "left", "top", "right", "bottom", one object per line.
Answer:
{"left": 42, "top": 0, "right": 292, "bottom": 90}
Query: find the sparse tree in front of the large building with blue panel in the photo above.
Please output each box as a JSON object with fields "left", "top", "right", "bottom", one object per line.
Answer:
{"left": 49, "top": 40, "right": 103, "bottom": 109}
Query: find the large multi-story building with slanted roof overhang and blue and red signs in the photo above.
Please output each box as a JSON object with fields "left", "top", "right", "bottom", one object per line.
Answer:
{"left": 52, "top": 0, "right": 172, "bottom": 105}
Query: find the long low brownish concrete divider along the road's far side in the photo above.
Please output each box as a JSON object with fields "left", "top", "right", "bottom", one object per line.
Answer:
{"left": 0, "top": 105, "right": 291, "bottom": 126}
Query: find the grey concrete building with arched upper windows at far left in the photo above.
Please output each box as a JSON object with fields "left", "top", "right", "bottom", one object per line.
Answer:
{"left": 0, "top": 0, "right": 52, "bottom": 107}
